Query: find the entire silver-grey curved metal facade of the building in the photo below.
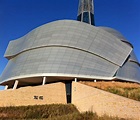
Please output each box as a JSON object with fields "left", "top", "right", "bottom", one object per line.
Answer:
{"left": 0, "top": 20, "right": 140, "bottom": 84}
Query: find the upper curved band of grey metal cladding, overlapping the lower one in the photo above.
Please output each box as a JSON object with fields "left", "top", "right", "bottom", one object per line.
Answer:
{"left": 5, "top": 20, "right": 132, "bottom": 66}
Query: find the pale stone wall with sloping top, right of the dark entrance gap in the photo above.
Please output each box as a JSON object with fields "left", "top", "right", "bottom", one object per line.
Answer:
{"left": 72, "top": 82, "right": 140, "bottom": 120}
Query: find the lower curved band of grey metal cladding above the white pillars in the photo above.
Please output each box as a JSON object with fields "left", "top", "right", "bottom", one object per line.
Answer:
{"left": 1, "top": 47, "right": 119, "bottom": 82}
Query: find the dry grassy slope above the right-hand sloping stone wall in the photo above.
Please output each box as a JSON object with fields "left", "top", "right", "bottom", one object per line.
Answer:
{"left": 81, "top": 81, "right": 140, "bottom": 101}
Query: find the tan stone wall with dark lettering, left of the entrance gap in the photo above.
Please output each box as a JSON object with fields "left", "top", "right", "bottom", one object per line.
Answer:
{"left": 0, "top": 83, "right": 66, "bottom": 107}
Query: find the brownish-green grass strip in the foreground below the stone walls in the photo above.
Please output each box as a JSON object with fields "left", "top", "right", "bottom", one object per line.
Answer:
{"left": 0, "top": 104, "right": 132, "bottom": 120}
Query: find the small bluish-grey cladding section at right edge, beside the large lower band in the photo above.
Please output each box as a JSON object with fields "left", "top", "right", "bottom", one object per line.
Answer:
{"left": 116, "top": 61, "right": 140, "bottom": 83}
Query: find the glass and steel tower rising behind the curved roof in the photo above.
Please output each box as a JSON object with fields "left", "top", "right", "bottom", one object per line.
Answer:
{"left": 77, "top": 0, "right": 95, "bottom": 25}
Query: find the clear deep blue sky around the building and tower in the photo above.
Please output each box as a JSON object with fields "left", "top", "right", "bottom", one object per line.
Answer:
{"left": 0, "top": 0, "right": 140, "bottom": 89}
